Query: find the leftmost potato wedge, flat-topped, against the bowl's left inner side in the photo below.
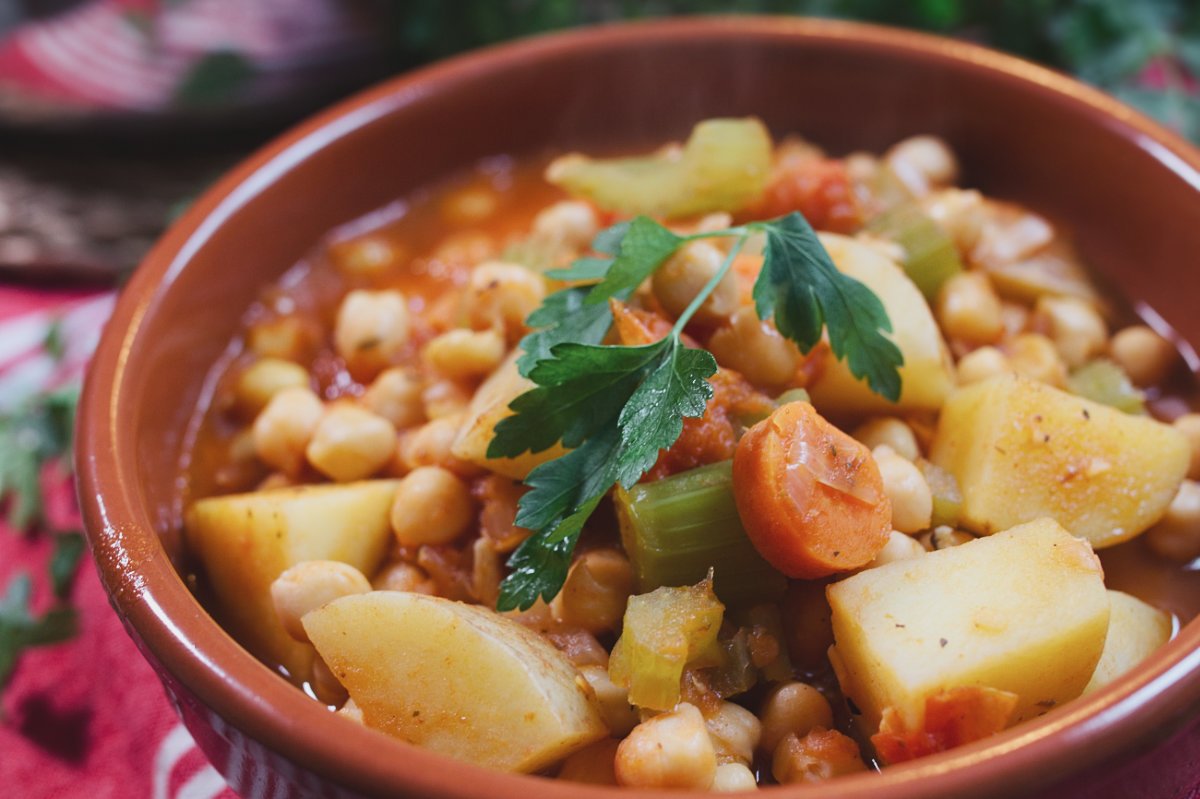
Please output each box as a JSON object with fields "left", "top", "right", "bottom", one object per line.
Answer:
{"left": 184, "top": 480, "right": 398, "bottom": 679}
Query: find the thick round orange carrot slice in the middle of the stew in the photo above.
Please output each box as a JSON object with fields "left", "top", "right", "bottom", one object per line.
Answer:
{"left": 733, "top": 402, "right": 892, "bottom": 579}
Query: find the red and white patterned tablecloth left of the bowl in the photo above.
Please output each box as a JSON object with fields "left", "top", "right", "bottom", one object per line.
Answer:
{"left": 0, "top": 287, "right": 235, "bottom": 799}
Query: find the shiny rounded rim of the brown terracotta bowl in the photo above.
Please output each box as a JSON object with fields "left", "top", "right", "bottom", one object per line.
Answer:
{"left": 76, "top": 16, "right": 1200, "bottom": 799}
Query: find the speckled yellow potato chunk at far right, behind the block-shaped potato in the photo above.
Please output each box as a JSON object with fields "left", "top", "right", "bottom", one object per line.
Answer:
{"left": 930, "top": 374, "right": 1190, "bottom": 548}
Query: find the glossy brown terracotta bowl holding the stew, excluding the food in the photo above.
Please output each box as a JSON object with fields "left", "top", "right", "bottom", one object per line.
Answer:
{"left": 78, "top": 18, "right": 1200, "bottom": 799}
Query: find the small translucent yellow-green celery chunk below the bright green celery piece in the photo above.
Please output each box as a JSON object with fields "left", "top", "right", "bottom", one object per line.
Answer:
{"left": 608, "top": 578, "right": 725, "bottom": 710}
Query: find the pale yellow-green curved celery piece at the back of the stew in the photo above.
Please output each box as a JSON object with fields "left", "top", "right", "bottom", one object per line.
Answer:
{"left": 546, "top": 118, "right": 772, "bottom": 218}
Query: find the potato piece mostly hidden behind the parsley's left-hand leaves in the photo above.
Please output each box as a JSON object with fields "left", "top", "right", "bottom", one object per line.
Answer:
{"left": 450, "top": 349, "right": 566, "bottom": 480}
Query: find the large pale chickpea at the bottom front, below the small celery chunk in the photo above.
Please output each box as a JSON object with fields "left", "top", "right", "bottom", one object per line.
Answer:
{"left": 614, "top": 702, "right": 716, "bottom": 791}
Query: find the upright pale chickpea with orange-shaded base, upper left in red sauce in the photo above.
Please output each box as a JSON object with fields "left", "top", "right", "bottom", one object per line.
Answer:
{"left": 334, "top": 289, "right": 412, "bottom": 377}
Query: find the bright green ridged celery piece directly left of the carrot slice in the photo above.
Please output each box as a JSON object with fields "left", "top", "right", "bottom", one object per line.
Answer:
{"left": 616, "top": 461, "right": 787, "bottom": 605}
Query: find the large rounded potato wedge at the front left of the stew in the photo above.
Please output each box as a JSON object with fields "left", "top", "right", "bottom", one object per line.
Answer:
{"left": 304, "top": 591, "right": 608, "bottom": 771}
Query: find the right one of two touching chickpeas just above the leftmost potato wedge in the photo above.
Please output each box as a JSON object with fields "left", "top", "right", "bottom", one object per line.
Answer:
{"left": 305, "top": 402, "right": 396, "bottom": 482}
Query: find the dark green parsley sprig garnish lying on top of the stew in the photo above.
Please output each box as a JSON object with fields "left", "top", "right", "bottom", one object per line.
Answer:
{"left": 487, "top": 214, "right": 904, "bottom": 611}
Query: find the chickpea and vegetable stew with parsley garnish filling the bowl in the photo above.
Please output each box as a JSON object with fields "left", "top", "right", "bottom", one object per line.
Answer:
{"left": 185, "top": 119, "right": 1200, "bottom": 791}
